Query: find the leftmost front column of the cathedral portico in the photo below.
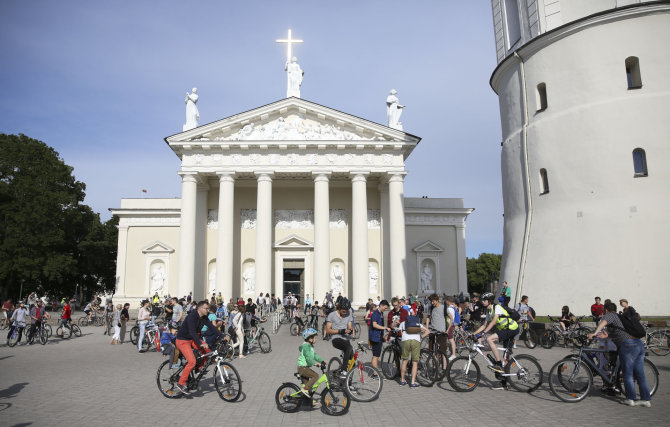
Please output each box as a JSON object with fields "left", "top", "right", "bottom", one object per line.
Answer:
{"left": 177, "top": 172, "right": 198, "bottom": 298}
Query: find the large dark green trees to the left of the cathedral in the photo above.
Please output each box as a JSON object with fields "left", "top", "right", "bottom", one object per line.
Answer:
{"left": 0, "top": 134, "right": 117, "bottom": 297}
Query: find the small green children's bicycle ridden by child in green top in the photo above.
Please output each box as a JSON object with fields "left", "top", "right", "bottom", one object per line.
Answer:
{"left": 275, "top": 368, "right": 351, "bottom": 416}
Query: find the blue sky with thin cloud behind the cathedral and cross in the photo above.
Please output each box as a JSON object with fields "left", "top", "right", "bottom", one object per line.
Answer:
{"left": 0, "top": 0, "right": 503, "bottom": 257}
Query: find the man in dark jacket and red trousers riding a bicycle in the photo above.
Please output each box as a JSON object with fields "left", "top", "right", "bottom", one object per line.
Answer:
{"left": 176, "top": 300, "right": 226, "bottom": 394}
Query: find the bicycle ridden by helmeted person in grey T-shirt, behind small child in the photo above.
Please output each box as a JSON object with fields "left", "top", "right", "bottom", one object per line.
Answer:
{"left": 328, "top": 342, "right": 384, "bottom": 402}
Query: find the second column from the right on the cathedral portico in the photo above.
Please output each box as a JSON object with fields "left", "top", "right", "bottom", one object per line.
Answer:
{"left": 350, "top": 172, "right": 369, "bottom": 307}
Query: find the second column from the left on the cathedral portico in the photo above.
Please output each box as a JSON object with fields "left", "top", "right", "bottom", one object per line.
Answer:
{"left": 216, "top": 172, "right": 235, "bottom": 301}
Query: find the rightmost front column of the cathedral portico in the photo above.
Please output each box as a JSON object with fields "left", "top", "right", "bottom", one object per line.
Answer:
{"left": 388, "top": 172, "right": 407, "bottom": 297}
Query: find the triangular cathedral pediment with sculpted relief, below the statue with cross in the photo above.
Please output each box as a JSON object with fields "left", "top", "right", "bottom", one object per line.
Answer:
{"left": 165, "top": 98, "right": 420, "bottom": 148}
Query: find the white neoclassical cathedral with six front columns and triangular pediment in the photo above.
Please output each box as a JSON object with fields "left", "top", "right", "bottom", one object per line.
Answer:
{"left": 112, "top": 96, "right": 473, "bottom": 305}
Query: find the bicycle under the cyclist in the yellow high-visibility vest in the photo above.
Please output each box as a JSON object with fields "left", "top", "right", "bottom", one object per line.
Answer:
{"left": 446, "top": 339, "right": 544, "bottom": 393}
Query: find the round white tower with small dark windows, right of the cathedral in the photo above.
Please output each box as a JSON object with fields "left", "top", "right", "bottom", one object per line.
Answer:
{"left": 491, "top": 0, "right": 670, "bottom": 315}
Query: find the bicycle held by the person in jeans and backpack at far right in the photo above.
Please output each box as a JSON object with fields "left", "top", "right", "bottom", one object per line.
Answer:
{"left": 549, "top": 341, "right": 658, "bottom": 403}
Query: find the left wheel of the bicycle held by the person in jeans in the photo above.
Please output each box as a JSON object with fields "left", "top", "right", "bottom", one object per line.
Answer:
{"left": 549, "top": 357, "right": 593, "bottom": 403}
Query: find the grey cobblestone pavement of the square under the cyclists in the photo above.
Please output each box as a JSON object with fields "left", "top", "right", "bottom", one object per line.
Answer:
{"left": 0, "top": 316, "right": 670, "bottom": 426}
